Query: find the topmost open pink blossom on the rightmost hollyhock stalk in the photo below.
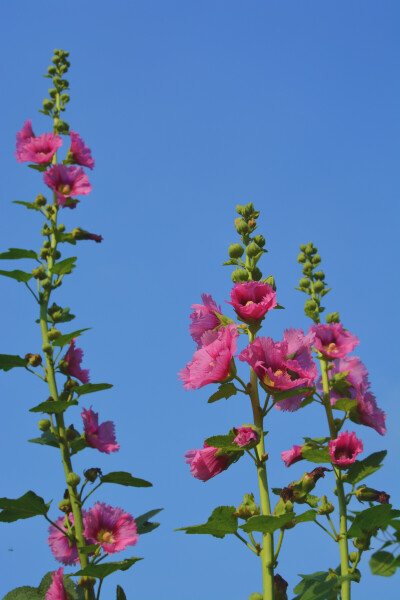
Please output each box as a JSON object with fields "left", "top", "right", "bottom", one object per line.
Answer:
{"left": 310, "top": 323, "right": 360, "bottom": 359}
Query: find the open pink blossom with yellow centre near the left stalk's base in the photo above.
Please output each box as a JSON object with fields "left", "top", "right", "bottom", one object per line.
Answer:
{"left": 85, "top": 502, "right": 139, "bottom": 554}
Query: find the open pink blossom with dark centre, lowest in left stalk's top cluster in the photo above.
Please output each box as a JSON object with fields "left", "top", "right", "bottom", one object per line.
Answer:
{"left": 43, "top": 165, "right": 92, "bottom": 206}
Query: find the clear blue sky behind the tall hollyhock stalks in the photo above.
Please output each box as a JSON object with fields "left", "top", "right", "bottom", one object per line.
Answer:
{"left": 0, "top": 0, "right": 400, "bottom": 600}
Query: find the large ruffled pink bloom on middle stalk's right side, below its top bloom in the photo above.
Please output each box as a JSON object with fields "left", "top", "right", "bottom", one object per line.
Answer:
{"left": 239, "top": 329, "right": 318, "bottom": 411}
